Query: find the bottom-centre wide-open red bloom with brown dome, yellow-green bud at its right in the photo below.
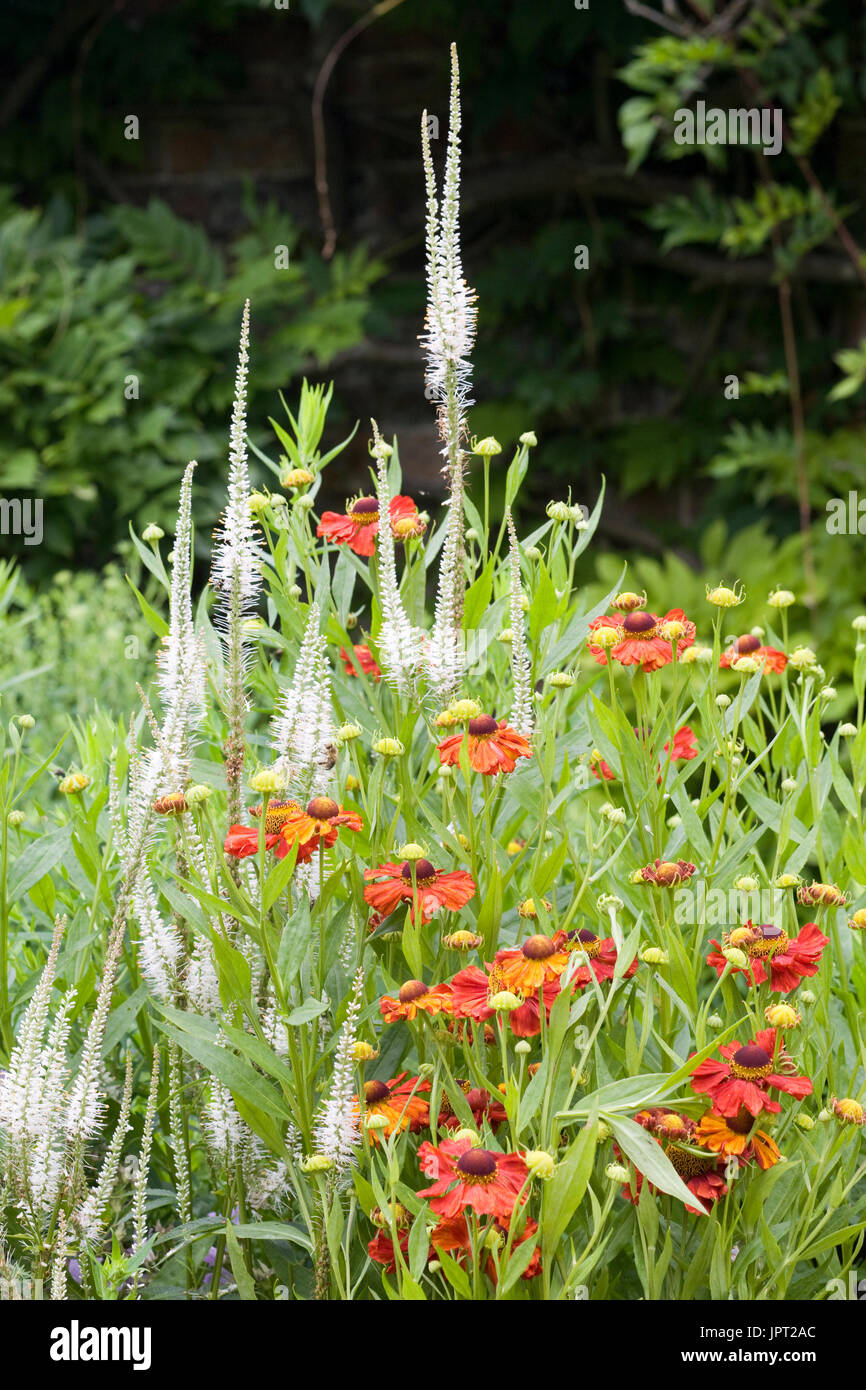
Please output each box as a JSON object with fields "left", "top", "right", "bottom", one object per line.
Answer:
{"left": 416, "top": 1138, "right": 528, "bottom": 1222}
